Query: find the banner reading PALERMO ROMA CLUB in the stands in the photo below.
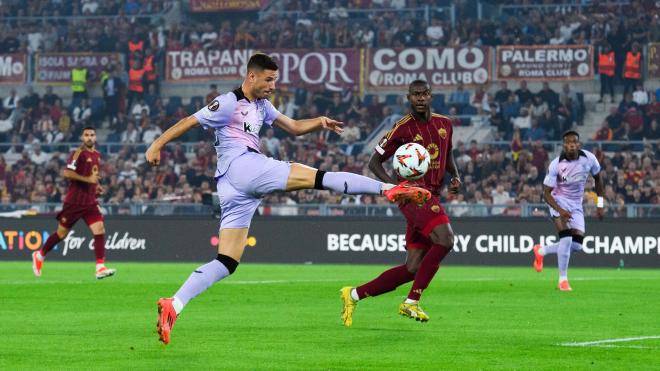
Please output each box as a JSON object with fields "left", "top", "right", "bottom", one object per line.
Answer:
{"left": 496, "top": 45, "right": 594, "bottom": 81}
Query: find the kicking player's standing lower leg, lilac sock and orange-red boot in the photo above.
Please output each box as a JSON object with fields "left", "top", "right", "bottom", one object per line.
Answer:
{"left": 156, "top": 254, "right": 238, "bottom": 344}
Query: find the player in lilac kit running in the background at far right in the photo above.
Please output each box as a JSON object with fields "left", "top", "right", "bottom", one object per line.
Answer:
{"left": 534, "top": 131, "right": 604, "bottom": 291}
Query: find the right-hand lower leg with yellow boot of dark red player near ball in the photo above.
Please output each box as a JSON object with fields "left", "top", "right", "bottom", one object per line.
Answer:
{"left": 399, "top": 244, "right": 451, "bottom": 322}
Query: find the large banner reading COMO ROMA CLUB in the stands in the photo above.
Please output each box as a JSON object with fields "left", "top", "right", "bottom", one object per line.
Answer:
{"left": 366, "top": 47, "right": 491, "bottom": 90}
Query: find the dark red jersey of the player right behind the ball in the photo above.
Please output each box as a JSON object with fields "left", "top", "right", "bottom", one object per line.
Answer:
{"left": 376, "top": 113, "right": 453, "bottom": 194}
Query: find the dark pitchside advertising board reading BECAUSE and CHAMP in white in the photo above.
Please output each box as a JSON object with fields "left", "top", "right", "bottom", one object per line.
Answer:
{"left": 0, "top": 217, "right": 660, "bottom": 269}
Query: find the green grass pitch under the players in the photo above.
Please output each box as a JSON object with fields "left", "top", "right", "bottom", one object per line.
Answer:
{"left": 0, "top": 262, "right": 660, "bottom": 370}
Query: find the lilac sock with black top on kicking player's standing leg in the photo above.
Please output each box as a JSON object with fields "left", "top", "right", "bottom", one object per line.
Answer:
{"left": 174, "top": 254, "right": 238, "bottom": 314}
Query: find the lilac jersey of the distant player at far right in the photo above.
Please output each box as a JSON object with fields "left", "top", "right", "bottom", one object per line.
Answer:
{"left": 543, "top": 150, "right": 600, "bottom": 206}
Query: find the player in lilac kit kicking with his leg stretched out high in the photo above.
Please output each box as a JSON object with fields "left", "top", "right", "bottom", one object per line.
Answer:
{"left": 146, "top": 54, "right": 431, "bottom": 344}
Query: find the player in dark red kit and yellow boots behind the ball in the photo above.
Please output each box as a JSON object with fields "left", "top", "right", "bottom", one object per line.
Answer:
{"left": 341, "top": 80, "right": 461, "bottom": 326}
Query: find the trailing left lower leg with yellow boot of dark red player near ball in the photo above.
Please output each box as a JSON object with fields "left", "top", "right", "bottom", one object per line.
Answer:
{"left": 340, "top": 264, "right": 415, "bottom": 327}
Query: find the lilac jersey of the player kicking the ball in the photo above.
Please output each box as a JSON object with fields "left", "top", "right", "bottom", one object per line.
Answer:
{"left": 194, "top": 88, "right": 280, "bottom": 178}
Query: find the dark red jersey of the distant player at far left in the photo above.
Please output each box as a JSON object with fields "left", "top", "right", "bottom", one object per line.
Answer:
{"left": 64, "top": 147, "right": 101, "bottom": 205}
